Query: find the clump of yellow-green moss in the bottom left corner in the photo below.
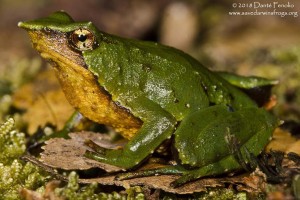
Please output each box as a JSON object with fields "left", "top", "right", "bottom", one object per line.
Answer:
{"left": 0, "top": 118, "right": 47, "bottom": 199}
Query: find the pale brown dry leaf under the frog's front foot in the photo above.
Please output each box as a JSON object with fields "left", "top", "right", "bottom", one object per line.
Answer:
{"left": 40, "top": 132, "right": 121, "bottom": 172}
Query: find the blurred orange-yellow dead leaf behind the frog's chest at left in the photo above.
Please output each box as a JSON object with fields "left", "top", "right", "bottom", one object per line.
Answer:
{"left": 13, "top": 70, "right": 74, "bottom": 134}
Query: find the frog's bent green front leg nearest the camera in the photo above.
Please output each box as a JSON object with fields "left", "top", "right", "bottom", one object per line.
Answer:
{"left": 85, "top": 97, "right": 176, "bottom": 169}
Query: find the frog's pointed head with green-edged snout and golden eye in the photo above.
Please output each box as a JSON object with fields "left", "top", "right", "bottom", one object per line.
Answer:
{"left": 18, "top": 11, "right": 101, "bottom": 67}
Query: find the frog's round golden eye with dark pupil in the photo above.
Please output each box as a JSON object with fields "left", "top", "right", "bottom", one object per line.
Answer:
{"left": 69, "top": 29, "right": 96, "bottom": 51}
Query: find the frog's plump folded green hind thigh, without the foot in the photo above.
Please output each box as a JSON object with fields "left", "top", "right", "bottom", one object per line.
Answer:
{"left": 175, "top": 105, "right": 276, "bottom": 170}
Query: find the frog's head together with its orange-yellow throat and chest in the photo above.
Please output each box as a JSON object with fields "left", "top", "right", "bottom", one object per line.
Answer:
{"left": 18, "top": 11, "right": 141, "bottom": 138}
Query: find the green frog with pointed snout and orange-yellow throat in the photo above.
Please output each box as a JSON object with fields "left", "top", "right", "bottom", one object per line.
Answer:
{"left": 18, "top": 11, "right": 280, "bottom": 187}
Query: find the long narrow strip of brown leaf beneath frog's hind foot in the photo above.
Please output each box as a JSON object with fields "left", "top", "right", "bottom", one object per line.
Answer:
{"left": 79, "top": 170, "right": 266, "bottom": 194}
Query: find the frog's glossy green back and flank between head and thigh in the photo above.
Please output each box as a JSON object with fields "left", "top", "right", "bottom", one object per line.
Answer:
{"left": 85, "top": 33, "right": 254, "bottom": 120}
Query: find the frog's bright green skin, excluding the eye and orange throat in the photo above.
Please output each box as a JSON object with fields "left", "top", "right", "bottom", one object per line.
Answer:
{"left": 19, "top": 12, "right": 278, "bottom": 186}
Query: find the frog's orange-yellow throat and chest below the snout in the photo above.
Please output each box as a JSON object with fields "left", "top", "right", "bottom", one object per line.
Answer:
{"left": 29, "top": 30, "right": 142, "bottom": 139}
